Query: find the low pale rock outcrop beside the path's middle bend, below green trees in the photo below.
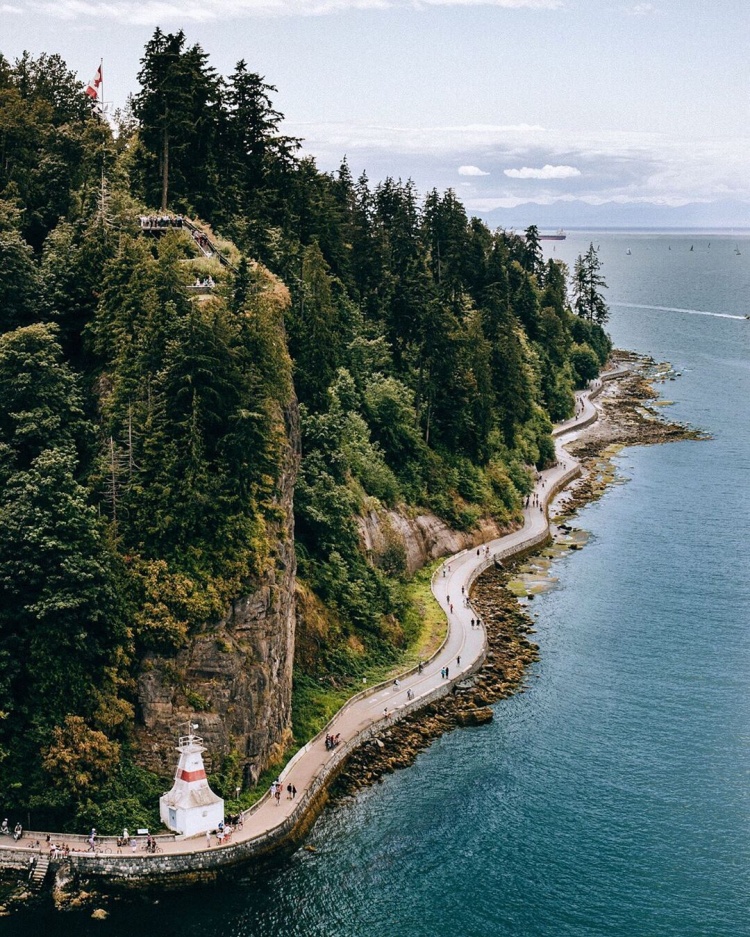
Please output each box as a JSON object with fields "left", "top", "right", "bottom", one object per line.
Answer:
{"left": 357, "top": 510, "right": 507, "bottom": 574}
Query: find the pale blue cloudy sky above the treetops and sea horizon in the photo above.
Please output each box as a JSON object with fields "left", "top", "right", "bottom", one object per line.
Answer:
{"left": 0, "top": 0, "right": 750, "bottom": 227}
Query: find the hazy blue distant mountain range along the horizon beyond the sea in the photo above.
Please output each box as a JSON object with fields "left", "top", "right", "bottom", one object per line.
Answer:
{"left": 476, "top": 201, "right": 750, "bottom": 231}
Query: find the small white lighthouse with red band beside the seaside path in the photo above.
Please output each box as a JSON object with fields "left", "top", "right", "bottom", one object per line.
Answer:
{"left": 159, "top": 722, "right": 224, "bottom": 836}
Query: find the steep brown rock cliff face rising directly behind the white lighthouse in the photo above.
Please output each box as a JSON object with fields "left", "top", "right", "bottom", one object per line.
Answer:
{"left": 138, "top": 401, "right": 299, "bottom": 796}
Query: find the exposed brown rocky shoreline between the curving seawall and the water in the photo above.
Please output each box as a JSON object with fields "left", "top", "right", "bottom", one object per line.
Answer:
{"left": 330, "top": 352, "right": 706, "bottom": 800}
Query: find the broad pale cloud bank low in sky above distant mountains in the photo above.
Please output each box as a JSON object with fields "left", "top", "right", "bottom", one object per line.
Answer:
{"left": 285, "top": 123, "right": 750, "bottom": 211}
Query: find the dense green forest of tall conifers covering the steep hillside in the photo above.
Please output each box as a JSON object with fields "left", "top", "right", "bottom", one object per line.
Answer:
{"left": 0, "top": 30, "right": 610, "bottom": 831}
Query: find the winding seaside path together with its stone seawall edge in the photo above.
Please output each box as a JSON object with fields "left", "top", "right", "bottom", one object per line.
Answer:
{"left": 3, "top": 369, "right": 627, "bottom": 877}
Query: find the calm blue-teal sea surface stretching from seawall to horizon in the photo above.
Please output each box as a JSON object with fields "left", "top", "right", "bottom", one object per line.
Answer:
{"left": 5, "top": 233, "right": 750, "bottom": 937}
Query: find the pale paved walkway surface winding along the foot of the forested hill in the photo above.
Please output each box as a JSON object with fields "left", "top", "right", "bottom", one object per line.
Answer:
{"left": 8, "top": 371, "right": 625, "bottom": 855}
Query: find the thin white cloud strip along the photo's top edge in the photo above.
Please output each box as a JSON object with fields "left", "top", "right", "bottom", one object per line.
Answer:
{"left": 32, "top": 0, "right": 565, "bottom": 25}
